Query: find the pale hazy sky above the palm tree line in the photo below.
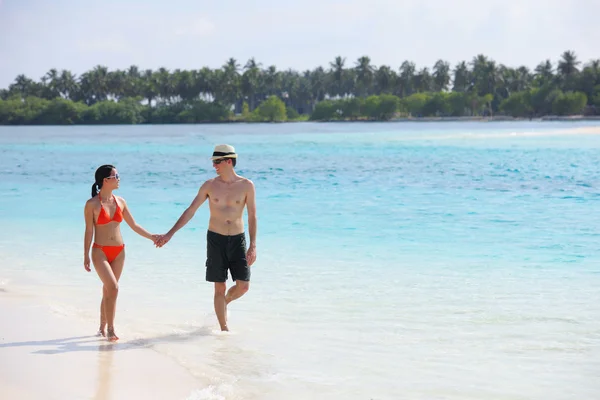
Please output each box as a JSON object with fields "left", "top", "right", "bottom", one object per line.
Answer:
{"left": 0, "top": 0, "right": 600, "bottom": 88}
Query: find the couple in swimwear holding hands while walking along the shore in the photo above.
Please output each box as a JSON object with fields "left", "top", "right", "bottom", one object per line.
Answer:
{"left": 84, "top": 145, "right": 257, "bottom": 341}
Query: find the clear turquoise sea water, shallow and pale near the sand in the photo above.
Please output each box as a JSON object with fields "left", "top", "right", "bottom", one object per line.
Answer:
{"left": 0, "top": 122, "right": 600, "bottom": 399}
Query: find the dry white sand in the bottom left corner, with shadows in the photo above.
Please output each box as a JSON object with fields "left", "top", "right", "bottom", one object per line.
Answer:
{"left": 0, "top": 291, "right": 202, "bottom": 400}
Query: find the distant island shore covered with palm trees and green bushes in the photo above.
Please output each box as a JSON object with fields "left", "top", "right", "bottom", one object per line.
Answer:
{"left": 0, "top": 51, "right": 600, "bottom": 125}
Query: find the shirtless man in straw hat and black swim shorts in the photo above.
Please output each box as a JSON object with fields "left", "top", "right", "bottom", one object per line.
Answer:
{"left": 156, "top": 144, "right": 256, "bottom": 331}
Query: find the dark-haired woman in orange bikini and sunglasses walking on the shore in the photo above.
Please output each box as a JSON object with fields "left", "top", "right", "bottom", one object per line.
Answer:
{"left": 83, "top": 165, "right": 159, "bottom": 341}
